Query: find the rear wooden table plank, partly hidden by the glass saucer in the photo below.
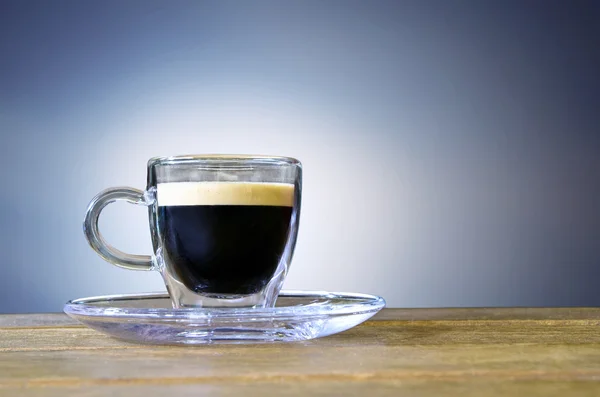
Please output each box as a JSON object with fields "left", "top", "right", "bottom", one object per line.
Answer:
{"left": 0, "top": 320, "right": 600, "bottom": 351}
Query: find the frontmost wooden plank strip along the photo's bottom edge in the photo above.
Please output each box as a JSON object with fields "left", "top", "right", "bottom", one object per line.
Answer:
{"left": 0, "top": 379, "right": 599, "bottom": 397}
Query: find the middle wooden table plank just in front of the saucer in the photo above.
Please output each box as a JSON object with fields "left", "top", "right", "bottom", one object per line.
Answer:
{"left": 0, "top": 345, "right": 600, "bottom": 380}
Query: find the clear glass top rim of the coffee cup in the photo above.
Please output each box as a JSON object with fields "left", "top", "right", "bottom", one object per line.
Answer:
{"left": 148, "top": 154, "right": 301, "bottom": 167}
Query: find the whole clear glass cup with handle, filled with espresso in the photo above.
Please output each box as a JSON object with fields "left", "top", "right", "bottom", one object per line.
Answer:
{"left": 84, "top": 155, "right": 302, "bottom": 308}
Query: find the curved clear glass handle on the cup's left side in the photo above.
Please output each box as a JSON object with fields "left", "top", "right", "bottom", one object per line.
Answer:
{"left": 83, "top": 187, "right": 154, "bottom": 270}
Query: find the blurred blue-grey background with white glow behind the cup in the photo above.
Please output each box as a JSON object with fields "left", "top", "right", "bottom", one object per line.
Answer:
{"left": 0, "top": 0, "right": 600, "bottom": 313}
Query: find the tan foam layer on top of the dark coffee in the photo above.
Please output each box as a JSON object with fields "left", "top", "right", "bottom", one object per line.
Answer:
{"left": 156, "top": 182, "right": 294, "bottom": 207}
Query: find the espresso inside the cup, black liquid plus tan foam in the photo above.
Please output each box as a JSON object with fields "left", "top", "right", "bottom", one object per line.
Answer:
{"left": 156, "top": 182, "right": 294, "bottom": 295}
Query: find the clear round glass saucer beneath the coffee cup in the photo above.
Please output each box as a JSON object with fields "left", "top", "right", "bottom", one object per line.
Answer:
{"left": 64, "top": 291, "right": 385, "bottom": 344}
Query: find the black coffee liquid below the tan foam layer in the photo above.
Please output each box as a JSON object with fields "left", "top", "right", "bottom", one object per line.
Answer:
{"left": 158, "top": 187, "right": 292, "bottom": 295}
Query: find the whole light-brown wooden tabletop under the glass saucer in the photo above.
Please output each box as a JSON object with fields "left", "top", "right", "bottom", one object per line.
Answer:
{"left": 0, "top": 308, "right": 600, "bottom": 397}
